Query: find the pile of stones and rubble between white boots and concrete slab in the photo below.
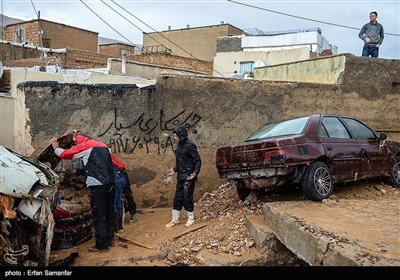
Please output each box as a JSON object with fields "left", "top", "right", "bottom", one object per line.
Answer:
{"left": 159, "top": 184, "right": 268, "bottom": 265}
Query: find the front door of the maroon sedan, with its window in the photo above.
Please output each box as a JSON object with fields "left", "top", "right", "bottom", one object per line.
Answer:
{"left": 342, "top": 117, "right": 392, "bottom": 178}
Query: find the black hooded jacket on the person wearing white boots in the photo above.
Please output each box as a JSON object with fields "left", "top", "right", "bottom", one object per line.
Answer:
{"left": 173, "top": 126, "right": 201, "bottom": 181}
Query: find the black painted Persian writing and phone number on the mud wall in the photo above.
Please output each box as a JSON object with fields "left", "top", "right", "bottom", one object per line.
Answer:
{"left": 98, "top": 108, "right": 201, "bottom": 154}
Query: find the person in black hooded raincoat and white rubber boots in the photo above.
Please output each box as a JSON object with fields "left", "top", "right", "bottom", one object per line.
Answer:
{"left": 165, "top": 126, "right": 201, "bottom": 228}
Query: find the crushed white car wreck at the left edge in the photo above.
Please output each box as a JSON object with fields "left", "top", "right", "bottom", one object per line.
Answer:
{"left": 0, "top": 146, "right": 60, "bottom": 266}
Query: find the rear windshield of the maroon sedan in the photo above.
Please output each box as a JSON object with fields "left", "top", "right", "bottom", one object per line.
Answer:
{"left": 245, "top": 117, "right": 310, "bottom": 142}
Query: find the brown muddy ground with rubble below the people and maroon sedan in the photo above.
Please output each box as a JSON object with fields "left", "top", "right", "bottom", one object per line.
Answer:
{"left": 51, "top": 174, "right": 400, "bottom": 267}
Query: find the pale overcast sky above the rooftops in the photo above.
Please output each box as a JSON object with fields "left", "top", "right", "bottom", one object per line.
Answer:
{"left": 0, "top": 0, "right": 400, "bottom": 59}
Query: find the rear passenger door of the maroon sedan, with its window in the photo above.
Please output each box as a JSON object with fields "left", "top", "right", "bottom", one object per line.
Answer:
{"left": 319, "top": 116, "right": 362, "bottom": 182}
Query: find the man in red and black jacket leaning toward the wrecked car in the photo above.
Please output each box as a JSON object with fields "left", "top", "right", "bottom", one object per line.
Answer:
{"left": 50, "top": 130, "right": 115, "bottom": 252}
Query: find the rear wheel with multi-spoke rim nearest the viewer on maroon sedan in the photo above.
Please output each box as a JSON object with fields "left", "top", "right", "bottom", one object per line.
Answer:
{"left": 301, "top": 161, "right": 333, "bottom": 201}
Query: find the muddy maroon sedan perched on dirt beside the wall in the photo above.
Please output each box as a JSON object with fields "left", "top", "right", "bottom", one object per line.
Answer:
{"left": 216, "top": 115, "right": 400, "bottom": 201}
